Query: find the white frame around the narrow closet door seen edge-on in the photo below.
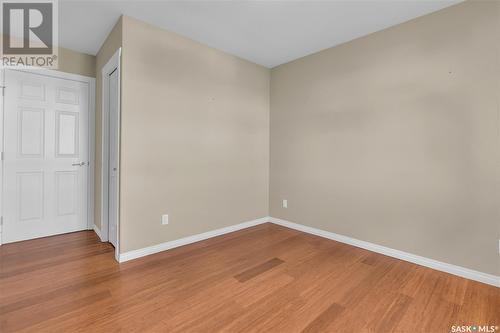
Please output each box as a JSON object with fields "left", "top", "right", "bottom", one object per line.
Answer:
{"left": 99, "top": 48, "right": 122, "bottom": 261}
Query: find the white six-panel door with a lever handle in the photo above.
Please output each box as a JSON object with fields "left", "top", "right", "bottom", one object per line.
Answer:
{"left": 2, "top": 70, "right": 89, "bottom": 243}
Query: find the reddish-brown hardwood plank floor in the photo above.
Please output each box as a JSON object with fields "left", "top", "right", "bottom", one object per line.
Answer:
{"left": 0, "top": 224, "right": 500, "bottom": 333}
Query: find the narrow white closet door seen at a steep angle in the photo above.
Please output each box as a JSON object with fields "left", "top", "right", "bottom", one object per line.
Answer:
{"left": 108, "top": 70, "right": 118, "bottom": 247}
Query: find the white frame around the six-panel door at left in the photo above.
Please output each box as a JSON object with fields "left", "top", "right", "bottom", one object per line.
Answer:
{"left": 0, "top": 67, "right": 95, "bottom": 245}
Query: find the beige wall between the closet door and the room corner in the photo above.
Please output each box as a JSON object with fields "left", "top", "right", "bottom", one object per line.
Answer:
{"left": 120, "top": 17, "right": 269, "bottom": 252}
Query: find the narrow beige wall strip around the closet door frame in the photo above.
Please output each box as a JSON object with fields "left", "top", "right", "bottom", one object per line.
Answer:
{"left": 94, "top": 18, "right": 122, "bottom": 228}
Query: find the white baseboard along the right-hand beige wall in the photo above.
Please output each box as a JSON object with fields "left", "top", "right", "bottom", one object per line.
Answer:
{"left": 269, "top": 217, "right": 500, "bottom": 287}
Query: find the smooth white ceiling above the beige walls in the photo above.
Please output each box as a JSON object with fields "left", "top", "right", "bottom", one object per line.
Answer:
{"left": 59, "top": 0, "right": 461, "bottom": 67}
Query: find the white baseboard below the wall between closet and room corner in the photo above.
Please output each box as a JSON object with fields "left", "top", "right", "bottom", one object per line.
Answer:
{"left": 118, "top": 217, "right": 269, "bottom": 262}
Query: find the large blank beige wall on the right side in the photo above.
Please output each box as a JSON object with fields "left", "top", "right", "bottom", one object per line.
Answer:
{"left": 270, "top": 1, "right": 500, "bottom": 275}
